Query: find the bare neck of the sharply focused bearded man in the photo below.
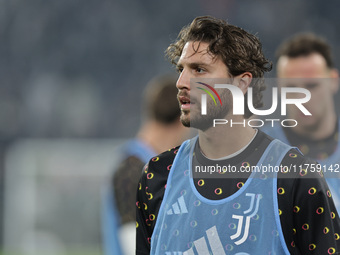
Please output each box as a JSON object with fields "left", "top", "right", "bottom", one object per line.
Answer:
{"left": 198, "top": 117, "right": 256, "bottom": 159}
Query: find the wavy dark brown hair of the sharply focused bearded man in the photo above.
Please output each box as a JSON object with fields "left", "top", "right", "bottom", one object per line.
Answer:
{"left": 165, "top": 16, "right": 272, "bottom": 118}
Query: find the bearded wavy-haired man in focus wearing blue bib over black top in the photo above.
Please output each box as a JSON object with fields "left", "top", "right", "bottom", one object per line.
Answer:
{"left": 136, "top": 17, "right": 340, "bottom": 255}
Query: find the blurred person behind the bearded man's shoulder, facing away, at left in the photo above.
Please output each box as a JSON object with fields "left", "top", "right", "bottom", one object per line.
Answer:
{"left": 103, "top": 74, "right": 189, "bottom": 255}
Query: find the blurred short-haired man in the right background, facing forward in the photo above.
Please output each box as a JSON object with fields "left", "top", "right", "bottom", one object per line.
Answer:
{"left": 264, "top": 33, "right": 340, "bottom": 212}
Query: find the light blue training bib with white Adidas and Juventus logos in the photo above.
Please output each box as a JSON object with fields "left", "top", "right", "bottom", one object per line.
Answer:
{"left": 151, "top": 138, "right": 291, "bottom": 255}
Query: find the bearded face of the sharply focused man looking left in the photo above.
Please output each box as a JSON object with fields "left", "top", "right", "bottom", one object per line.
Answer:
{"left": 176, "top": 42, "right": 232, "bottom": 130}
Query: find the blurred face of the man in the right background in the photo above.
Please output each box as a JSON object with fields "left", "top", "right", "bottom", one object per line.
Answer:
{"left": 277, "top": 53, "right": 337, "bottom": 131}
